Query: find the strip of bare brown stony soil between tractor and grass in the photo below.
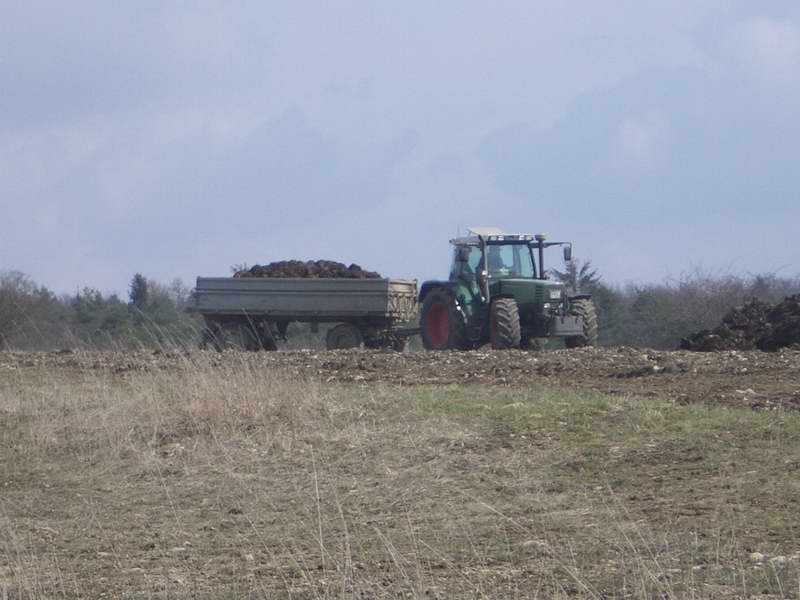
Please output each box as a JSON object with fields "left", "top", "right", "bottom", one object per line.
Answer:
{"left": 6, "top": 347, "right": 800, "bottom": 409}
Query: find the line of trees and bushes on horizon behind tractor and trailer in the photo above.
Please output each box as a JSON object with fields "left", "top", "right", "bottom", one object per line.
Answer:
{"left": 0, "top": 260, "right": 800, "bottom": 350}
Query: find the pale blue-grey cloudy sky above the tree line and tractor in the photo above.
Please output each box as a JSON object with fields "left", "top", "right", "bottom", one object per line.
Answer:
{"left": 0, "top": 0, "right": 800, "bottom": 293}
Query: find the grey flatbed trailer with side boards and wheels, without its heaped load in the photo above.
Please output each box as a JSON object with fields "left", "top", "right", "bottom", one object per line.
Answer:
{"left": 190, "top": 277, "right": 419, "bottom": 350}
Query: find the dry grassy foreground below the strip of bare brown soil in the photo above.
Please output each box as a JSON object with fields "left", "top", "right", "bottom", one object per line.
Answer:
{"left": 0, "top": 354, "right": 800, "bottom": 599}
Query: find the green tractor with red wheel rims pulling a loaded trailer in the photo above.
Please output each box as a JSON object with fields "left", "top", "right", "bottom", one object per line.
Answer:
{"left": 419, "top": 229, "right": 597, "bottom": 350}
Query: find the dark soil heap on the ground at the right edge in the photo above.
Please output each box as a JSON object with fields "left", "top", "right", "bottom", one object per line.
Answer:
{"left": 681, "top": 295, "right": 800, "bottom": 352}
